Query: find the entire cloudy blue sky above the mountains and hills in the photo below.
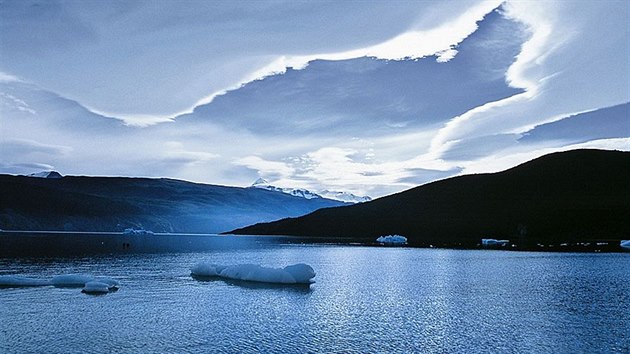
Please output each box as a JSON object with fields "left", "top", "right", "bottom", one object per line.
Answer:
{"left": 0, "top": 0, "right": 630, "bottom": 197}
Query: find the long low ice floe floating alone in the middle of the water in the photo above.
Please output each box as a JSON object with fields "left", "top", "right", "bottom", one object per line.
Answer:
{"left": 191, "top": 262, "right": 315, "bottom": 284}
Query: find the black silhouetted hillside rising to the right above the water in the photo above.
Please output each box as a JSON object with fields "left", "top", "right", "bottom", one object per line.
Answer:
{"left": 232, "top": 150, "right": 630, "bottom": 246}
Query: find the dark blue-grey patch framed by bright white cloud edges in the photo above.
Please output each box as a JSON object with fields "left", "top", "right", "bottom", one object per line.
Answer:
{"left": 177, "top": 8, "right": 524, "bottom": 138}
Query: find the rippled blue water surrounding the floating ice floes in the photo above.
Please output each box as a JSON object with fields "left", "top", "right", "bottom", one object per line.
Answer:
{"left": 0, "top": 245, "right": 630, "bottom": 353}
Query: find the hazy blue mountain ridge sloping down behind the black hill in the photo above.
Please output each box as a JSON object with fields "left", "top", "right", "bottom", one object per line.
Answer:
{"left": 0, "top": 175, "right": 344, "bottom": 233}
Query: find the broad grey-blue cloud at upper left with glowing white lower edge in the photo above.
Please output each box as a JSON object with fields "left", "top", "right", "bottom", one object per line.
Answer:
{"left": 0, "top": 0, "right": 500, "bottom": 119}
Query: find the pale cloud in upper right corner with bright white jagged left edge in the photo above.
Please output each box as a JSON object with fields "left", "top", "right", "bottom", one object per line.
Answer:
{"left": 431, "top": 1, "right": 630, "bottom": 156}
